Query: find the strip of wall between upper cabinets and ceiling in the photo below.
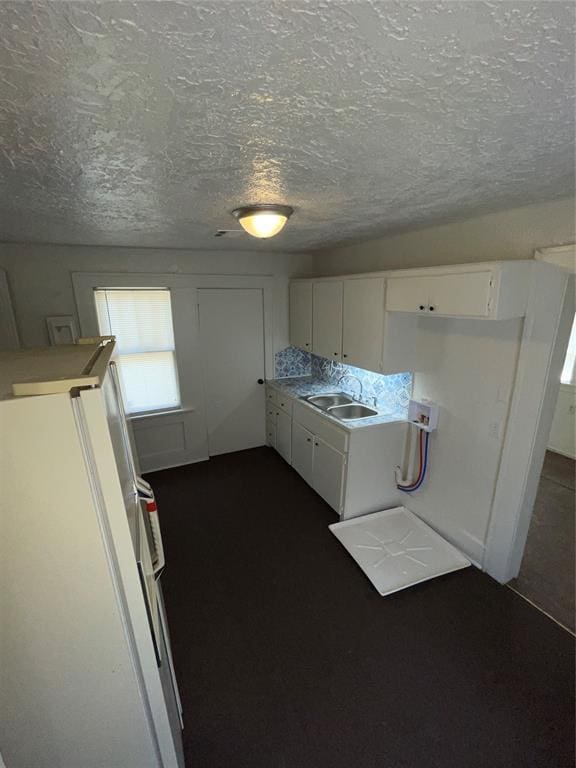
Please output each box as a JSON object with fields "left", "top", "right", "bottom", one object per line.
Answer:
{"left": 315, "top": 198, "right": 576, "bottom": 275}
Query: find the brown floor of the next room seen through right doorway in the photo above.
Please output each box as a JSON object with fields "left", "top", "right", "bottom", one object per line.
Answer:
{"left": 510, "top": 451, "right": 576, "bottom": 632}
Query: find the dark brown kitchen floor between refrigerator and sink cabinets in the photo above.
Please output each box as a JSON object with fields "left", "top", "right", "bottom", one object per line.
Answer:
{"left": 148, "top": 448, "right": 574, "bottom": 768}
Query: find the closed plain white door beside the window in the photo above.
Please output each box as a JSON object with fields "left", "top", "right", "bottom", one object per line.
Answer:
{"left": 198, "top": 288, "right": 266, "bottom": 456}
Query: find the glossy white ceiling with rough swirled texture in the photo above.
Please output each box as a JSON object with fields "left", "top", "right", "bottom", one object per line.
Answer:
{"left": 0, "top": 0, "right": 574, "bottom": 250}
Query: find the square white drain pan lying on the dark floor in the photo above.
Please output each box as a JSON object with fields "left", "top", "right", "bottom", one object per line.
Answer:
{"left": 329, "top": 507, "right": 470, "bottom": 595}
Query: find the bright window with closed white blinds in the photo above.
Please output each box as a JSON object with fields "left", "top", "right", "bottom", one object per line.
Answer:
{"left": 94, "top": 288, "right": 180, "bottom": 413}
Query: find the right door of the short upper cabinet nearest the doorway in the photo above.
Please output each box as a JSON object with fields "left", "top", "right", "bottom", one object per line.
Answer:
{"left": 428, "top": 271, "right": 492, "bottom": 317}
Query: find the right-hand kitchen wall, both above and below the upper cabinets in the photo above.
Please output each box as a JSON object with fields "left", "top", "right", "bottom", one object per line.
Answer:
{"left": 315, "top": 200, "right": 576, "bottom": 563}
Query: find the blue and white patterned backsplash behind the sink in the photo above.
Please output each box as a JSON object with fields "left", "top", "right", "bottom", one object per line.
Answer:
{"left": 275, "top": 347, "right": 412, "bottom": 412}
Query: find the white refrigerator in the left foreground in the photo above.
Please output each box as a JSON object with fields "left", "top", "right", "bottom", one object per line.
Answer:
{"left": 0, "top": 339, "right": 184, "bottom": 768}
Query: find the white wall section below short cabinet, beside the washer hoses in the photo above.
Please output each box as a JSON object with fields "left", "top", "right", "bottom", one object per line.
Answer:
{"left": 404, "top": 318, "right": 523, "bottom": 563}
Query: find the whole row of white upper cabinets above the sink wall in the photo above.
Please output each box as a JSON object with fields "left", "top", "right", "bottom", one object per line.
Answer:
{"left": 290, "top": 261, "right": 532, "bottom": 373}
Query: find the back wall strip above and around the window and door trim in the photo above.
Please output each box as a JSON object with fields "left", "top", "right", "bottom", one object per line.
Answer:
{"left": 0, "top": 243, "right": 314, "bottom": 350}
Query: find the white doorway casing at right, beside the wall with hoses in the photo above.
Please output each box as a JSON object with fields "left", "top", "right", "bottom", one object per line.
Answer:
{"left": 484, "top": 246, "right": 575, "bottom": 584}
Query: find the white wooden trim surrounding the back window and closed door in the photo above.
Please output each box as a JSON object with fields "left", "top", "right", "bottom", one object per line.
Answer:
{"left": 71, "top": 271, "right": 274, "bottom": 472}
